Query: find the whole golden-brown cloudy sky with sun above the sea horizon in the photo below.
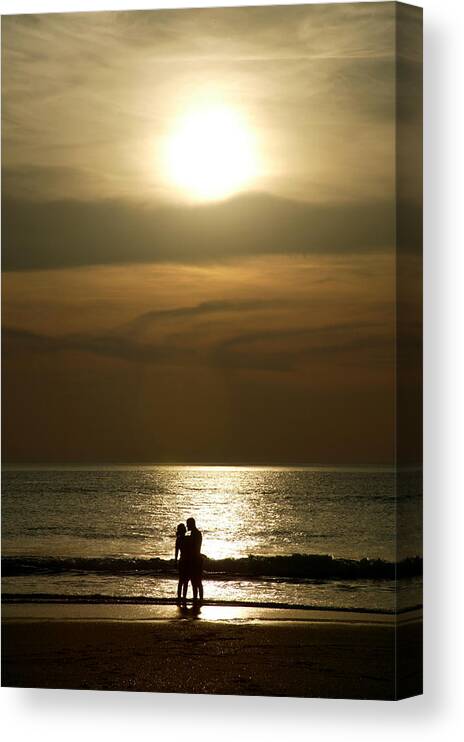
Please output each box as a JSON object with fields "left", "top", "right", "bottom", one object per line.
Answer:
{"left": 2, "top": 3, "right": 421, "bottom": 464}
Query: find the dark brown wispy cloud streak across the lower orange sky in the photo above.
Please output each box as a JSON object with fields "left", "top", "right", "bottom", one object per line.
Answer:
{"left": 3, "top": 294, "right": 410, "bottom": 371}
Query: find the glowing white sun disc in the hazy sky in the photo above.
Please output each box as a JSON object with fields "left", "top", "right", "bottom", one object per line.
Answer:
{"left": 166, "top": 106, "right": 257, "bottom": 200}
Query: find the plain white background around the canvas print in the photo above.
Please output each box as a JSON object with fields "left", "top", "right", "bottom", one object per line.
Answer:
{"left": 0, "top": 0, "right": 464, "bottom": 742}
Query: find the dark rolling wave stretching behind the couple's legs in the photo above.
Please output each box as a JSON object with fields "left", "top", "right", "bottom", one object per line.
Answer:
{"left": 2, "top": 554, "right": 422, "bottom": 580}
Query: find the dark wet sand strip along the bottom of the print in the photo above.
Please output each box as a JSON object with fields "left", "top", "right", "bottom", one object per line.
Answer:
{"left": 2, "top": 603, "right": 422, "bottom": 700}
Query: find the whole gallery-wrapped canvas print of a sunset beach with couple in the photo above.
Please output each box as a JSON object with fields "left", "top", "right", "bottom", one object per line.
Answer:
{"left": 2, "top": 2, "right": 422, "bottom": 700}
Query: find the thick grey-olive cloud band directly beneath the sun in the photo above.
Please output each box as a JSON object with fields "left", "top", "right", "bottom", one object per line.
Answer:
{"left": 2, "top": 194, "right": 406, "bottom": 271}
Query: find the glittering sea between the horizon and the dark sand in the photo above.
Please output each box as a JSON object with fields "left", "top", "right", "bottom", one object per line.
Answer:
{"left": 2, "top": 465, "right": 422, "bottom": 611}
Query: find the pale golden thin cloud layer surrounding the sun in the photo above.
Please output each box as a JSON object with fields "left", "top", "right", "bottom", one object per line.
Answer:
{"left": 2, "top": 3, "right": 417, "bottom": 208}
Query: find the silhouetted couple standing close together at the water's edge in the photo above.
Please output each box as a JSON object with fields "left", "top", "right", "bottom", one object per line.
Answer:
{"left": 175, "top": 518, "right": 203, "bottom": 602}
